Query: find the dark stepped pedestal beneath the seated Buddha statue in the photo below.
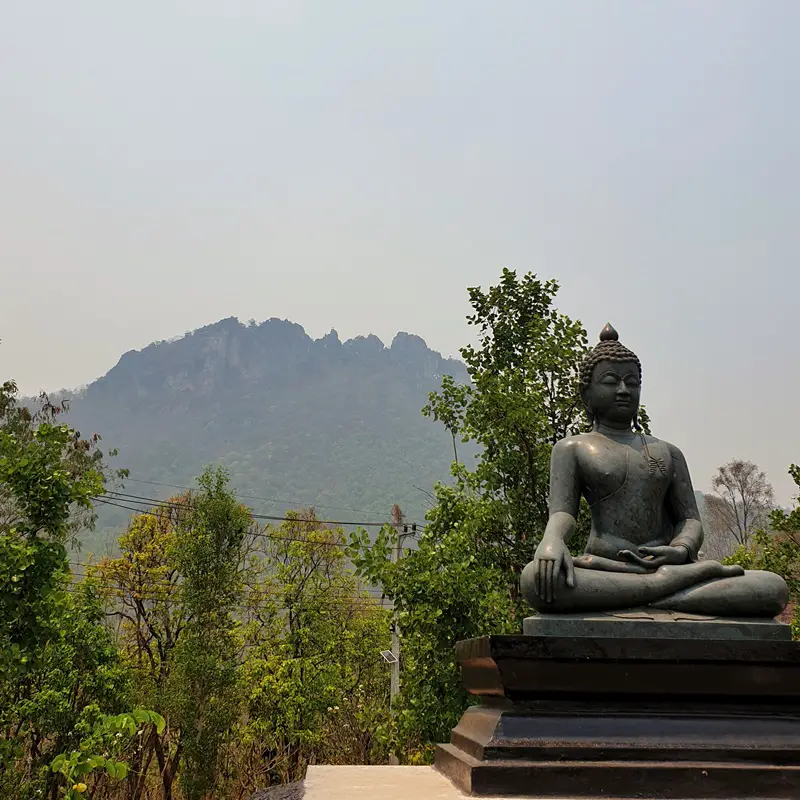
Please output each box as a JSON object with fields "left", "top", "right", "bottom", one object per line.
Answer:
{"left": 436, "top": 635, "right": 800, "bottom": 800}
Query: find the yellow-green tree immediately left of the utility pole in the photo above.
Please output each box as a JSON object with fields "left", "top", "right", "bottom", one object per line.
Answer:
{"left": 239, "top": 509, "right": 390, "bottom": 790}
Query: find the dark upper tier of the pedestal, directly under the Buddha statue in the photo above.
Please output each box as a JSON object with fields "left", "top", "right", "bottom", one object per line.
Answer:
{"left": 456, "top": 635, "right": 800, "bottom": 704}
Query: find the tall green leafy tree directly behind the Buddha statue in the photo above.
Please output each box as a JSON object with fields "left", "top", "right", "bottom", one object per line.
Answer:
{"left": 351, "top": 269, "right": 589, "bottom": 761}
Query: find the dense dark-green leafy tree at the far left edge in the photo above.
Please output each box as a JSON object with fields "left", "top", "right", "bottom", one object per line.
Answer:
{"left": 0, "top": 382, "right": 127, "bottom": 798}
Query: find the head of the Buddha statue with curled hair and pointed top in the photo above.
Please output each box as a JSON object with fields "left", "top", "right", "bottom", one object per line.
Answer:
{"left": 580, "top": 324, "right": 642, "bottom": 430}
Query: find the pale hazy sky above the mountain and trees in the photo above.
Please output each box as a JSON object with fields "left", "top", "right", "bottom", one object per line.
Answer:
{"left": 0, "top": 0, "right": 800, "bottom": 501}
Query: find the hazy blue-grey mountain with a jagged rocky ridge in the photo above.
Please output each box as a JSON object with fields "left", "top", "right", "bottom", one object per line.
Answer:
{"left": 59, "top": 318, "right": 474, "bottom": 551}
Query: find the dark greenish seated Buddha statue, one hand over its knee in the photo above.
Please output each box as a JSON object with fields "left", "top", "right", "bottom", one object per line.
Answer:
{"left": 521, "top": 325, "right": 788, "bottom": 619}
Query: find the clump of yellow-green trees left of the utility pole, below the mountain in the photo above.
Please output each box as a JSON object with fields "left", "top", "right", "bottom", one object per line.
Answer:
{"left": 83, "top": 478, "right": 389, "bottom": 798}
